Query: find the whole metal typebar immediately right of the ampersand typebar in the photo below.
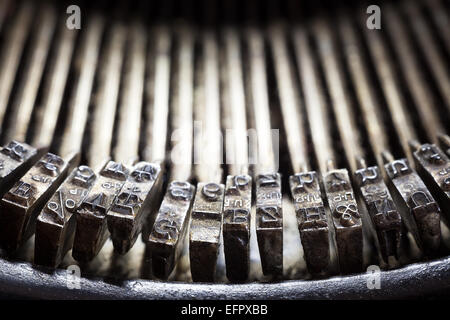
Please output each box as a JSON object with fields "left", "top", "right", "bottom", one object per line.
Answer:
{"left": 319, "top": 15, "right": 402, "bottom": 262}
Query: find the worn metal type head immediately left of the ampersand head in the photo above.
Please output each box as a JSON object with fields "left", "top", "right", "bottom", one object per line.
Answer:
{"left": 289, "top": 171, "right": 330, "bottom": 275}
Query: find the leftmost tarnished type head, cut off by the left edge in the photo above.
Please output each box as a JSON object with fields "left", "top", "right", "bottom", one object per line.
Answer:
{"left": 0, "top": 140, "right": 45, "bottom": 197}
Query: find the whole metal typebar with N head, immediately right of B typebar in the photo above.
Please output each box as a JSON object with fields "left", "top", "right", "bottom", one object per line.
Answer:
{"left": 246, "top": 27, "right": 283, "bottom": 277}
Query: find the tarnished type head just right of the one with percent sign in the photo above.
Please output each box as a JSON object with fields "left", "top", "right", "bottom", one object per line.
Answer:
{"left": 72, "top": 161, "right": 129, "bottom": 262}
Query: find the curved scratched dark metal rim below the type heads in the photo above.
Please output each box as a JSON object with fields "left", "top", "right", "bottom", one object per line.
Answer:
{"left": 0, "top": 256, "right": 450, "bottom": 300}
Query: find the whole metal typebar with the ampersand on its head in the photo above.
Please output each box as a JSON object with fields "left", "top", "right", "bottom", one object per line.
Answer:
{"left": 294, "top": 25, "right": 363, "bottom": 273}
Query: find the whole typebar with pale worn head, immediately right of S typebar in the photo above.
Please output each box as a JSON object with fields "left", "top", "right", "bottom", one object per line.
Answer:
{"left": 189, "top": 31, "right": 225, "bottom": 282}
